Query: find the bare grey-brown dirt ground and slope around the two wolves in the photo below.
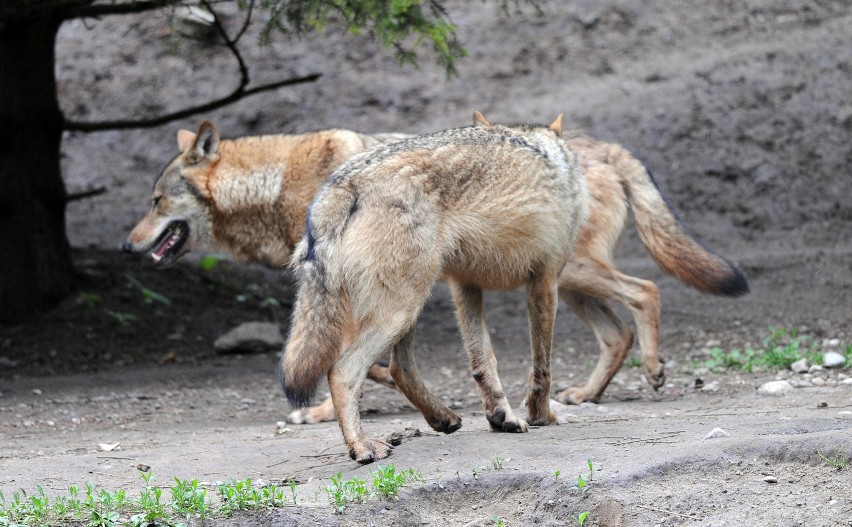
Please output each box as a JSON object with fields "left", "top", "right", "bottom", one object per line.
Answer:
{"left": 0, "top": 0, "right": 852, "bottom": 526}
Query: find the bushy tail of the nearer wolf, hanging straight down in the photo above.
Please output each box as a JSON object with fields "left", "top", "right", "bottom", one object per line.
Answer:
{"left": 280, "top": 184, "right": 354, "bottom": 406}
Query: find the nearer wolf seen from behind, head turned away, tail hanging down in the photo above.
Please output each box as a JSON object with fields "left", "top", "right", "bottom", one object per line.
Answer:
{"left": 281, "top": 115, "right": 588, "bottom": 463}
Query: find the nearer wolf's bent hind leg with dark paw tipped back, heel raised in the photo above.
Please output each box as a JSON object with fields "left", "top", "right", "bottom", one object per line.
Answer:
{"left": 390, "top": 326, "right": 461, "bottom": 434}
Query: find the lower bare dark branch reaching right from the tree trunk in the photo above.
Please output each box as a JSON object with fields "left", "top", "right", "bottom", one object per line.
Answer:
{"left": 63, "top": 73, "right": 322, "bottom": 132}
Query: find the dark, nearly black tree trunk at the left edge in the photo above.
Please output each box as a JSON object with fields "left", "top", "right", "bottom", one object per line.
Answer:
{"left": 0, "top": 18, "right": 74, "bottom": 323}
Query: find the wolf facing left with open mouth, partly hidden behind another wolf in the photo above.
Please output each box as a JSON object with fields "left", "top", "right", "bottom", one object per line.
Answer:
{"left": 124, "top": 115, "right": 748, "bottom": 423}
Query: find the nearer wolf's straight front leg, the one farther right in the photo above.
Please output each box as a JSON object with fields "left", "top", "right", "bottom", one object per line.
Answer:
{"left": 527, "top": 270, "right": 557, "bottom": 426}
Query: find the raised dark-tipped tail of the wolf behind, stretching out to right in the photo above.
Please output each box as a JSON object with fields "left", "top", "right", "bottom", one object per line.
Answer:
{"left": 609, "top": 145, "right": 749, "bottom": 296}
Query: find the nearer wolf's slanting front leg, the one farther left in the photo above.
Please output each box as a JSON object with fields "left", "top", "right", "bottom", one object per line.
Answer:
{"left": 450, "top": 282, "right": 527, "bottom": 432}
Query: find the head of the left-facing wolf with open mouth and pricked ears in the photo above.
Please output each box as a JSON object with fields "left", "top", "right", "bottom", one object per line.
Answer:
{"left": 122, "top": 121, "right": 219, "bottom": 267}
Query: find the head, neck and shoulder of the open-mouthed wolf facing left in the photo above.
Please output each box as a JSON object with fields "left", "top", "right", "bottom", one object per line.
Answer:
{"left": 124, "top": 121, "right": 377, "bottom": 266}
